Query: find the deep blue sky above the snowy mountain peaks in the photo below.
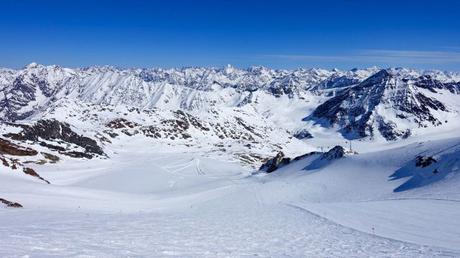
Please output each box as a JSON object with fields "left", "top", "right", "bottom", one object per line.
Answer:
{"left": 0, "top": 0, "right": 460, "bottom": 71}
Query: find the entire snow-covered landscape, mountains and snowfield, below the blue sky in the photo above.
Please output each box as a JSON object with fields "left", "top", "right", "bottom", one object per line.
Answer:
{"left": 0, "top": 63, "right": 460, "bottom": 257}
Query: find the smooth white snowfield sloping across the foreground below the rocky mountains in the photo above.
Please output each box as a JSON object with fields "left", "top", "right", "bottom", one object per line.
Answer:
{"left": 0, "top": 138, "right": 460, "bottom": 257}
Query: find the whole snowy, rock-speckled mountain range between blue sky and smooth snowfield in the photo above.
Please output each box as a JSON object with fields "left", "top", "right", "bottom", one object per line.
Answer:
{"left": 0, "top": 63, "right": 460, "bottom": 167}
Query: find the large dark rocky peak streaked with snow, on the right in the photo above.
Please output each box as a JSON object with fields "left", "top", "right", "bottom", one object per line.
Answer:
{"left": 304, "top": 69, "right": 458, "bottom": 141}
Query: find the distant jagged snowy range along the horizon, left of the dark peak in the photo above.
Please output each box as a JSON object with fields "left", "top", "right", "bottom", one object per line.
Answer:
{"left": 0, "top": 63, "right": 374, "bottom": 120}
